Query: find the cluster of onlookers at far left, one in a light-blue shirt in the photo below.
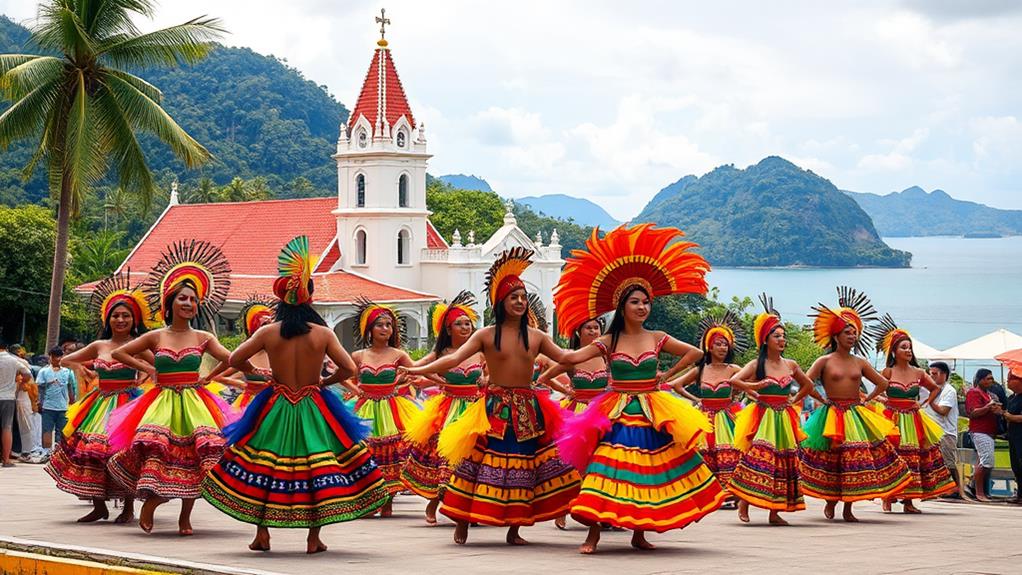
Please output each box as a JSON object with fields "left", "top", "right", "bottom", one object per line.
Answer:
{"left": 0, "top": 340, "right": 82, "bottom": 467}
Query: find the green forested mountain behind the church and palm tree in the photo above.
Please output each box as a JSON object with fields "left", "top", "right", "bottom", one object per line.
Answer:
{"left": 0, "top": 17, "right": 345, "bottom": 204}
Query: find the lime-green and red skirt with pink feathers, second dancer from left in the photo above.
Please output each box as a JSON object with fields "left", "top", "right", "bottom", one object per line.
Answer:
{"left": 107, "top": 385, "right": 235, "bottom": 499}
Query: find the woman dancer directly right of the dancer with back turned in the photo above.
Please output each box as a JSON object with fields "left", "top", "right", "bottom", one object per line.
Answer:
{"left": 350, "top": 298, "right": 419, "bottom": 517}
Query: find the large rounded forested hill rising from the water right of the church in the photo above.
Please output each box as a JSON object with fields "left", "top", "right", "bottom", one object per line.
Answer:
{"left": 635, "top": 156, "right": 912, "bottom": 267}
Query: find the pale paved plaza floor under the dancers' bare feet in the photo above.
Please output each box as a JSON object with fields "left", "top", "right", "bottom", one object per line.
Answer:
{"left": 0, "top": 465, "right": 1022, "bottom": 575}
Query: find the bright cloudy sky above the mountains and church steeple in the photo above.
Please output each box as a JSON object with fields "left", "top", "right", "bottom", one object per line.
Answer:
{"left": 0, "top": 0, "right": 1022, "bottom": 219}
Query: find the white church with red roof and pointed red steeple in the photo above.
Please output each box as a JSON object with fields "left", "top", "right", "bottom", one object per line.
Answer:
{"left": 87, "top": 18, "right": 564, "bottom": 349}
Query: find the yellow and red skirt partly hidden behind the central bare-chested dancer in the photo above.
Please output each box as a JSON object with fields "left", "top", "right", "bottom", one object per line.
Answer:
{"left": 401, "top": 385, "right": 479, "bottom": 499}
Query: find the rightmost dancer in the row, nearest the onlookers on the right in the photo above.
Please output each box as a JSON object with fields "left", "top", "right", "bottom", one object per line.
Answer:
{"left": 872, "top": 315, "right": 957, "bottom": 514}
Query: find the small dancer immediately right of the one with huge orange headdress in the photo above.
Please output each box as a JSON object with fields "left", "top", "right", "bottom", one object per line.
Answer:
{"left": 669, "top": 310, "right": 748, "bottom": 509}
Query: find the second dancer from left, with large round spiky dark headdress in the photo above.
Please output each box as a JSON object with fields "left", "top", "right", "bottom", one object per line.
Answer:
{"left": 107, "top": 241, "right": 233, "bottom": 535}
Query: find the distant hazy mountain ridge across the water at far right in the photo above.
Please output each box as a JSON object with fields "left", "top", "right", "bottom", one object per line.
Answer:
{"left": 845, "top": 186, "right": 1022, "bottom": 237}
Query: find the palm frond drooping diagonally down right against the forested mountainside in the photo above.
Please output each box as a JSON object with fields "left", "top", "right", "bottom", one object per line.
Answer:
{"left": 100, "top": 73, "right": 212, "bottom": 167}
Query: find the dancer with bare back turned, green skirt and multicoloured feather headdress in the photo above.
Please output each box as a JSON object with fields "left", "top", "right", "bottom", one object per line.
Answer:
{"left": 202, "top": 236, "right": 389, "bottom": 554}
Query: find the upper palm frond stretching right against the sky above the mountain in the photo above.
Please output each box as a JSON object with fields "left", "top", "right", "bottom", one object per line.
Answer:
{"left": 96, "top": 16, "right": 226, "bottom": 67}
